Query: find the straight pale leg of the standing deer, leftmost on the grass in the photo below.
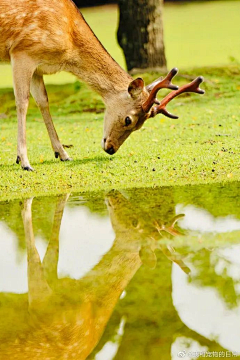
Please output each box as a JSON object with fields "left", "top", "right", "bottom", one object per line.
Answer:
{"left": 11, "top": 53, "right": 36, "bottom": 171}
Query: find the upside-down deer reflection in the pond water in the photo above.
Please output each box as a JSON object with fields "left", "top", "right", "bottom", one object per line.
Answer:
{"left": 0, "top": 191, "right": 189, "bottom": 360}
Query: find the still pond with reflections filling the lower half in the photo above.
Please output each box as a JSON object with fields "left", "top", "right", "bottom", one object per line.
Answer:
{"left": 0, "top": 182, "right": 240, "bottom": 360}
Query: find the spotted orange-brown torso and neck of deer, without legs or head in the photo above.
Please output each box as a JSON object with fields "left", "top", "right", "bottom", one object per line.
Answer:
{"left": 0, "top": 0, "right": 131, "bottom": 88}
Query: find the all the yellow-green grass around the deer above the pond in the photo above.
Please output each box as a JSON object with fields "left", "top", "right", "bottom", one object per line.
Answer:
{"left": 0, "top": 1, "right": 240, "bottom": 200}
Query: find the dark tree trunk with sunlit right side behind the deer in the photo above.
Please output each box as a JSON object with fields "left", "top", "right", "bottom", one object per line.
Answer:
{"left": 117, "top": 0, "right": 167, "bottom": 71}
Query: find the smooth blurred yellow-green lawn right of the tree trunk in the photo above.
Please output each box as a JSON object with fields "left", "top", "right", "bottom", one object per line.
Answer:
{"left": 164, "top": 1, "right": 240, "bottom": 68}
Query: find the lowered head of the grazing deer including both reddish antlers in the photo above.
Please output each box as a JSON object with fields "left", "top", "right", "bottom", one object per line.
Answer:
{"left": 102, "top": 68, "right": 204, "bottom": 155}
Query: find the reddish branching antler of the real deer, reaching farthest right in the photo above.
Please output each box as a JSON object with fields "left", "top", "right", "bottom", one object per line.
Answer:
{"left": 150, "top": 76, "right": 205, "bottom": 119}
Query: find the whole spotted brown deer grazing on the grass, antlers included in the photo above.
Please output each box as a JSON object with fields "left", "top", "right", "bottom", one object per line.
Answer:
{"left": 0, "top": 0, "right": 204, "bottom": 171}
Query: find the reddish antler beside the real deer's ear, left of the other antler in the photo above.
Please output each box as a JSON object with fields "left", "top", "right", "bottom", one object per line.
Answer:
{"left": 142, "top": 68, "right": 178, "bottom": 113}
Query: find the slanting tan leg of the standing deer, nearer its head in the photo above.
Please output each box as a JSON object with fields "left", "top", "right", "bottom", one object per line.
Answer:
{"left": 30, "top": 73, "right": 71, "bottom": 161}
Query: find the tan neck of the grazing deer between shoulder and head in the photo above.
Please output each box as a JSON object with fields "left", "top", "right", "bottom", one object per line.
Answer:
{"left": 67, "top": 14, "right": 132, "bottom": 102}
